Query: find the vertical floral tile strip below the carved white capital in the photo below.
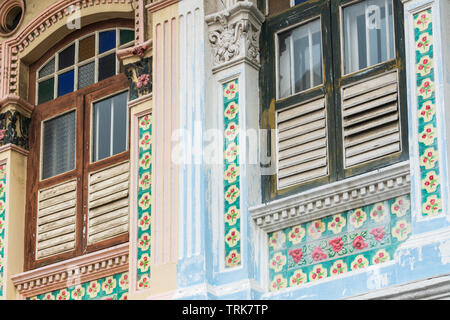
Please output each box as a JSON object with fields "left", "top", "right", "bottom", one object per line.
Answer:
{"left": 223, "top": 79, "right": 241, "bottom": 268}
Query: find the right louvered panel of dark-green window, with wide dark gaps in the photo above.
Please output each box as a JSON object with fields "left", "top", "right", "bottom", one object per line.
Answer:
{"left": 342, "top": 71, "right": 401, "bottom": 168}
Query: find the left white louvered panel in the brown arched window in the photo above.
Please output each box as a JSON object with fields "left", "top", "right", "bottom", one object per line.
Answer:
{"left": 36, "top": 180, "right": 77, "bottom": 259}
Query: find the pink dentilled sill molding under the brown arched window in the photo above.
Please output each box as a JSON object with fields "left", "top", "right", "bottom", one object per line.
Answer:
{"left": 11, "top": 243, "right": 129, "bottom": 298}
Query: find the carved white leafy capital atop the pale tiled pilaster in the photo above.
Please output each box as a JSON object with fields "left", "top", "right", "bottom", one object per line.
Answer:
{"left": 205, "top": 1, "right": 265, "bottom": 73}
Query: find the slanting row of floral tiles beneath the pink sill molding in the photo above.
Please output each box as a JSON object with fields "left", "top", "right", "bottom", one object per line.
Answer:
{"left": 28, "top": 272, "right": 129, "bottom": 300}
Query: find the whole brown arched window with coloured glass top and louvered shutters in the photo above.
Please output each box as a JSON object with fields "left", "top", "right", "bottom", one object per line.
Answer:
{"left": 26, "top": 20, "right": 134, "bottom": 269}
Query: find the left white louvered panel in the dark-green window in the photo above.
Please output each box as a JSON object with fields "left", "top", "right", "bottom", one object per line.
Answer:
{"left": 277, "top": 97, "right": 328, "bottom": 189}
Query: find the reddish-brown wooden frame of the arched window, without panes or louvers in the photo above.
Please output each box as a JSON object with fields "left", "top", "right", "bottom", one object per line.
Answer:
{"left": 24, "top": 19, "right": 133, "bottom": 270}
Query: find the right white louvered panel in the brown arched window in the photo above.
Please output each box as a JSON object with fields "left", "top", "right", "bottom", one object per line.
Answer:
{"left": 87, "top": 161, "right": 130, "bottom": 244}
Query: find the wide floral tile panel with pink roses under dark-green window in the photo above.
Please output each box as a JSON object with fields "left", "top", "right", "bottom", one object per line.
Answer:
{"left": 268, "top": 195, "right": 411, "bottom": 291}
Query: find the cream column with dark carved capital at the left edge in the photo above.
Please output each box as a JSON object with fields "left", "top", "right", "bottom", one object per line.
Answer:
{"left": 0, "top": 95, "right": 33, "bottom": 300}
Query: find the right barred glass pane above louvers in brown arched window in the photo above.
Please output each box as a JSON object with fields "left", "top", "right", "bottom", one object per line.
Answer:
{"left": 92, "top": 92, "right": 128, "bottom": 162}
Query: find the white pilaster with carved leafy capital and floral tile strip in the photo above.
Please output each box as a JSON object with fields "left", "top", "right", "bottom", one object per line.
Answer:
{"left": 205, "top": 1, "right": 264, "bottom": 299}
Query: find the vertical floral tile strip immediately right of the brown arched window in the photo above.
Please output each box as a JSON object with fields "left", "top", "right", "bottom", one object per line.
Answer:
{"left": 136, "top": 114, "right": 152, "bottom": 290}
